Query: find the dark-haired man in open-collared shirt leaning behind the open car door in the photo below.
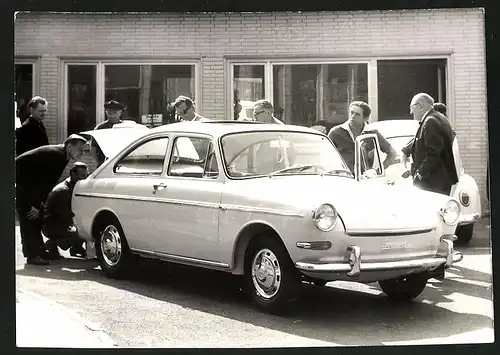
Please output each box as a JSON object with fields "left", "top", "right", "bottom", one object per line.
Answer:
{"left": 328, "top": 101, "right": 396, "bottom": 173}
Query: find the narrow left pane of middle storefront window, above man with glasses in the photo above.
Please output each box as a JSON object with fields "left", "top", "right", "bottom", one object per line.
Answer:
{"left": 232, "top": 65, "right": 265, "bottom": 120}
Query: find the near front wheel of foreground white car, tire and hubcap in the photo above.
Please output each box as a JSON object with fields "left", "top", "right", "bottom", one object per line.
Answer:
{"left": 244, "top": 236, "right": 301, "bottom": 314}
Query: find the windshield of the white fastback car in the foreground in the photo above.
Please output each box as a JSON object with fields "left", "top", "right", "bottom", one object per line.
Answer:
{"left": 221, "top": 131, "right": 353, "bottom": 178}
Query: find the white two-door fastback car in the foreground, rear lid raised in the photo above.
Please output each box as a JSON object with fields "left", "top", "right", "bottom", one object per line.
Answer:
{"left": 72, "top": 121, "right": 462, "bottom": 312}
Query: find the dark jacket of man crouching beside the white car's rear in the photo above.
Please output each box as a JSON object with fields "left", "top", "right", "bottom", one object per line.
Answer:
{"left": 44, "top": 178, "right": 75, "bottom": 230}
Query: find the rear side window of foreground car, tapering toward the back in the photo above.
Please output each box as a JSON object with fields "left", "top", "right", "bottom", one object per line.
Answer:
{"left": 113, "top": 137, "right": 169, "bottom": 175}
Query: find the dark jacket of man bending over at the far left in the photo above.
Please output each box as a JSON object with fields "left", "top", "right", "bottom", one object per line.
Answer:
{"left": 15, "top": 144, "right": 69, "bottom": 214}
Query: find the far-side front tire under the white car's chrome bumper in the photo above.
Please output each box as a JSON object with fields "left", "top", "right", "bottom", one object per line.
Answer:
{"left": 378, "top": 273, "right": 429, "bottom": 301}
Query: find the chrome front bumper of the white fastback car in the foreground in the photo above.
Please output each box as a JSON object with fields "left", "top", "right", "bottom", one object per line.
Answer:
{"left": 295, "top": 235, "right": 463, "bottom": 277}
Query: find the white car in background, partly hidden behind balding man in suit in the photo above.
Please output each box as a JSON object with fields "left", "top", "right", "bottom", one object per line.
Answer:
{"left": 370, "top": 119, "right": 481, "bottom": 245}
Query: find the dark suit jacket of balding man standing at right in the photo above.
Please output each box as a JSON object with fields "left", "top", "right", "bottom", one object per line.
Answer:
{"left": 410, "top": 110, "right": 458, "bottom": 192}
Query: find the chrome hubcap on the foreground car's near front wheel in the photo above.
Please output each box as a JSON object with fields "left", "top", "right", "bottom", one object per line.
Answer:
{"left": 252, "top": 249, "right": 281, "bottom": 299}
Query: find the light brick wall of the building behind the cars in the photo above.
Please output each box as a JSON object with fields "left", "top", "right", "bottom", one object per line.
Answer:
{"left": 15, "top": 9, "right": 487, "bottom": 208}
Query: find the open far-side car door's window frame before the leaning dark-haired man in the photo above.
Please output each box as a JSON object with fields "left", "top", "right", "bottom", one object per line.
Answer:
{"left": 354, "top": 133, "right": 385, "bottom": 181}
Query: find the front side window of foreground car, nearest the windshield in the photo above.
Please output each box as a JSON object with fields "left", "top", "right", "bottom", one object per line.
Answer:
{"left": 168, "top": 137, "right": 219, "bottom": 178}
